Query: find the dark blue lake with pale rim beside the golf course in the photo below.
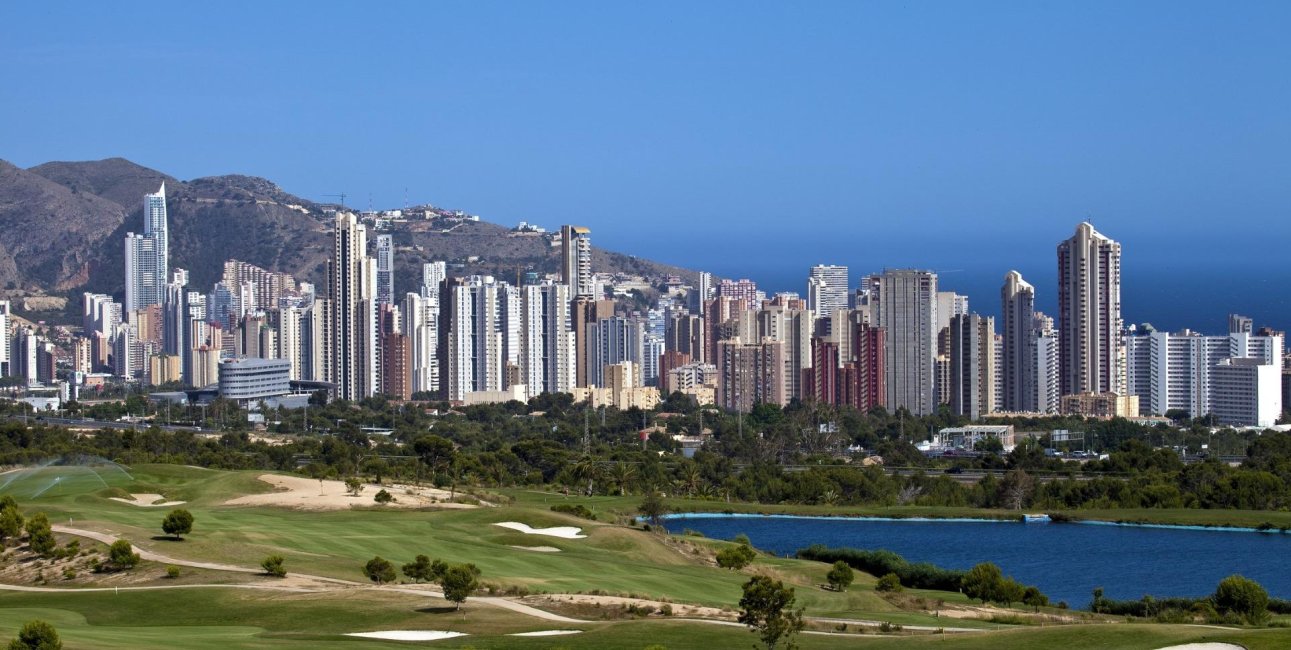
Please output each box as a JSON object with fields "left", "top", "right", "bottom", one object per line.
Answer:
{"left": 666, "top": 514, "right": 1291, "bottom": 609}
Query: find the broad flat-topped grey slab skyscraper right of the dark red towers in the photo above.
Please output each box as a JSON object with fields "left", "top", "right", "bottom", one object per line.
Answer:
{"left": 870, "top": 269, "right": 937, "bottom": 415}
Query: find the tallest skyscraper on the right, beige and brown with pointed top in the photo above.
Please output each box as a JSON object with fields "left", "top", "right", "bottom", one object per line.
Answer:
{"left": 1057, "top": 221, "right": 1124, "bottom": 395}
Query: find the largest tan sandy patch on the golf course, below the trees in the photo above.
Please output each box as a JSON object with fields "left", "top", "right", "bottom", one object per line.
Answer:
{"left": 225, "top": 474, "right": 476, "bottom": 510}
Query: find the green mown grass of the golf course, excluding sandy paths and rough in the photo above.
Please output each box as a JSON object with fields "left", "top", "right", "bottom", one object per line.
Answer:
{"left": 0, "top": 465, "right": 1291, "bottom": 647}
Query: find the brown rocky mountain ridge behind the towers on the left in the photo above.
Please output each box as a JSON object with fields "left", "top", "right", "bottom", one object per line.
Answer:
{"left": 0, "top": 158, "right": 695, "bottom": 319}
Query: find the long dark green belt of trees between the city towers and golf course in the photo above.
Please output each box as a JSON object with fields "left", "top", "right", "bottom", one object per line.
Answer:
{"left": 0, "top": 394, "right": 1291, "bottom": 509}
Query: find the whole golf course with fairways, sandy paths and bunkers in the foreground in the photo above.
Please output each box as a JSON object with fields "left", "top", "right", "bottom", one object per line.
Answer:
{"left": 0, "top": 461, "right": 1291, "bottom": 649}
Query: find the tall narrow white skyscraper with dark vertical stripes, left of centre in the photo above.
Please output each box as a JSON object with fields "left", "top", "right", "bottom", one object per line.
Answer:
{"left": 327, "top": 212, "right": 377, "bottom": 401}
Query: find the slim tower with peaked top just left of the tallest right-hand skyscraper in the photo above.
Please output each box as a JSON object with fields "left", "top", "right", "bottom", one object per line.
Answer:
{"left": 997, "top": 271, "right": 1039, "bottom": 412}
